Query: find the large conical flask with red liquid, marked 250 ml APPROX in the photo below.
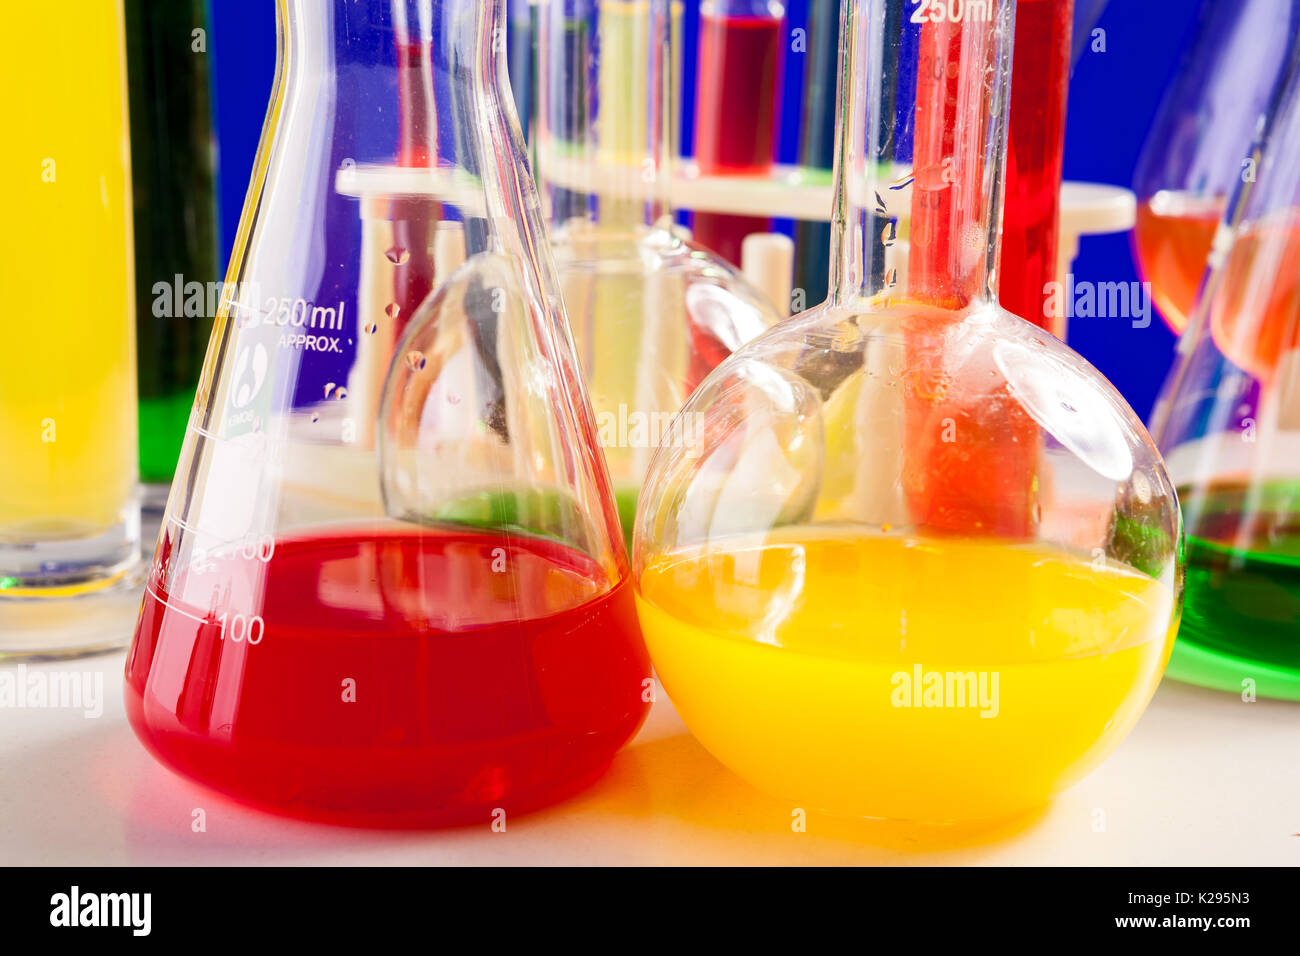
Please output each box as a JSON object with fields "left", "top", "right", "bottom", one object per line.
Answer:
{"left": 126, "top": 0, "right": 650, "bottom": 826}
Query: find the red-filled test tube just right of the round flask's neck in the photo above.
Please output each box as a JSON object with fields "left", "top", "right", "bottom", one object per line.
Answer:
{"left": 997, "top": 0, "right": 1074, "bottom": 339}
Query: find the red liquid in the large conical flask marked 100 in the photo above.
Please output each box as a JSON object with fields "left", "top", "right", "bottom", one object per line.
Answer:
{"left": 126, "top": 529, "right": 651, "bottom": 826}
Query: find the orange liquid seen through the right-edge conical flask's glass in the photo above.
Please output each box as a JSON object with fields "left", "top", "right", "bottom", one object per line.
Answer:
{"left": 1210, "top": 209, "right": 1300, "bottom": 382}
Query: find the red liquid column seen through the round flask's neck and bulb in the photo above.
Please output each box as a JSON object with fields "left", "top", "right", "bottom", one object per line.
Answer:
{"left": 904, "top": 18, "right": 1039, "bottom": 538}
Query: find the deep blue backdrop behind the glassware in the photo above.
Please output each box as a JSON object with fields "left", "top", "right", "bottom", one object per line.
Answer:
{"left": 209, "top": 0, "right": 1199, "bottom": 419}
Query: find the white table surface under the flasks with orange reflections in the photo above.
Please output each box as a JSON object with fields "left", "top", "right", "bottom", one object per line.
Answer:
{"left": 0, "top": 652, "right": 1300, "bottom": 865}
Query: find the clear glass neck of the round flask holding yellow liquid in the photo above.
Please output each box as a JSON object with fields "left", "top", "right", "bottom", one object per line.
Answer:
{"left": 829, "top": 0, "right": 1015, "bottom": 308}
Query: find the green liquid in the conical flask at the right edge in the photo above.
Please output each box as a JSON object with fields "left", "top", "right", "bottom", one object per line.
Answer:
{"left": 1169, "top": 483, "right": 1300, "bottom": 700}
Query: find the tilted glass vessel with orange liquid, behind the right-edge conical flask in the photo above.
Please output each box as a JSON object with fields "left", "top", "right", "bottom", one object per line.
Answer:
{"left": 1132, "top": 0, "right": 1296, "bottom": 332}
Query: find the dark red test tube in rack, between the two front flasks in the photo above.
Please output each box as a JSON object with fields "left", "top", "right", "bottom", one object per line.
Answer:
{"left": 692, "top": 0, "right": 789, "bottom": 263}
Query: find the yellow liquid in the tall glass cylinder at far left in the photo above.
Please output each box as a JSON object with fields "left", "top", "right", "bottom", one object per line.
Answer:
{"left": 0, "top": 0, "right": 137, "bottom": 540}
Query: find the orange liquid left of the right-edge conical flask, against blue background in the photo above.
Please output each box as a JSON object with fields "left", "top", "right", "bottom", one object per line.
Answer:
{"left": 1134, "top": 191, "right": 1225, "bottom": 332}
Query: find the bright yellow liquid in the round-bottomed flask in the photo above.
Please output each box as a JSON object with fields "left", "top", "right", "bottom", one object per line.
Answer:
{"left": 637, "top": 529, "right": 1175, "bottom": 823}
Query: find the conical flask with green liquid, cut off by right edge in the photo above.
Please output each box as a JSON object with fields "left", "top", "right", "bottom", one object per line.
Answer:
{"left": 1152, "top": 31, "right": 1300, "bottom": 700}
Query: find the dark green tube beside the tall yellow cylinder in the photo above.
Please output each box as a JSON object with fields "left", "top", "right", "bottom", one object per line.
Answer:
{"left": 126, "top": 0, "right": 220, "bottom": 510}
